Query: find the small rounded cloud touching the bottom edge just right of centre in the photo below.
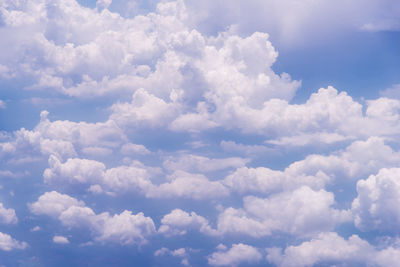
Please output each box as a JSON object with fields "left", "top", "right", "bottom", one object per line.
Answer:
{"left": 207, "top": 243, "right": 262, "bottom": 266}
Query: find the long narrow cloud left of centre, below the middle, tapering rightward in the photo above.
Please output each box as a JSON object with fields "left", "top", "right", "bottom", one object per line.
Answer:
{"left": 43, "top": 156, "right": 229, "bottom": 199}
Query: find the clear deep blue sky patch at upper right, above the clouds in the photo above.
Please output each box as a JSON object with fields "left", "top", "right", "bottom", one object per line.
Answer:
{"left": 273, "top": 31, "right": 400, "bottom": 103}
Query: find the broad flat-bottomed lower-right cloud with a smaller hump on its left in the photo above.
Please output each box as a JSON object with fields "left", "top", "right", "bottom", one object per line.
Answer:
{"left": 158, "top": 187, "right": 352, "bottom": 241}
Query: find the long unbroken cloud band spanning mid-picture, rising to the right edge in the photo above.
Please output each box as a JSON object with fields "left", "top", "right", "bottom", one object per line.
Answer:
{"left": 36, "top": 137, "right": 400, "bottom": 206}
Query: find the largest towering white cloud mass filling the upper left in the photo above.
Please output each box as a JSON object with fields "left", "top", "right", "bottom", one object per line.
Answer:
{"left": 3, "top": 0, "right": 318, "bottom": 139}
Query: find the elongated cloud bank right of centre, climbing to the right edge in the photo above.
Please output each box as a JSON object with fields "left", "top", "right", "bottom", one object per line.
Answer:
{"left": 222, "top": 137, "right": 400, "bottom": 194}
